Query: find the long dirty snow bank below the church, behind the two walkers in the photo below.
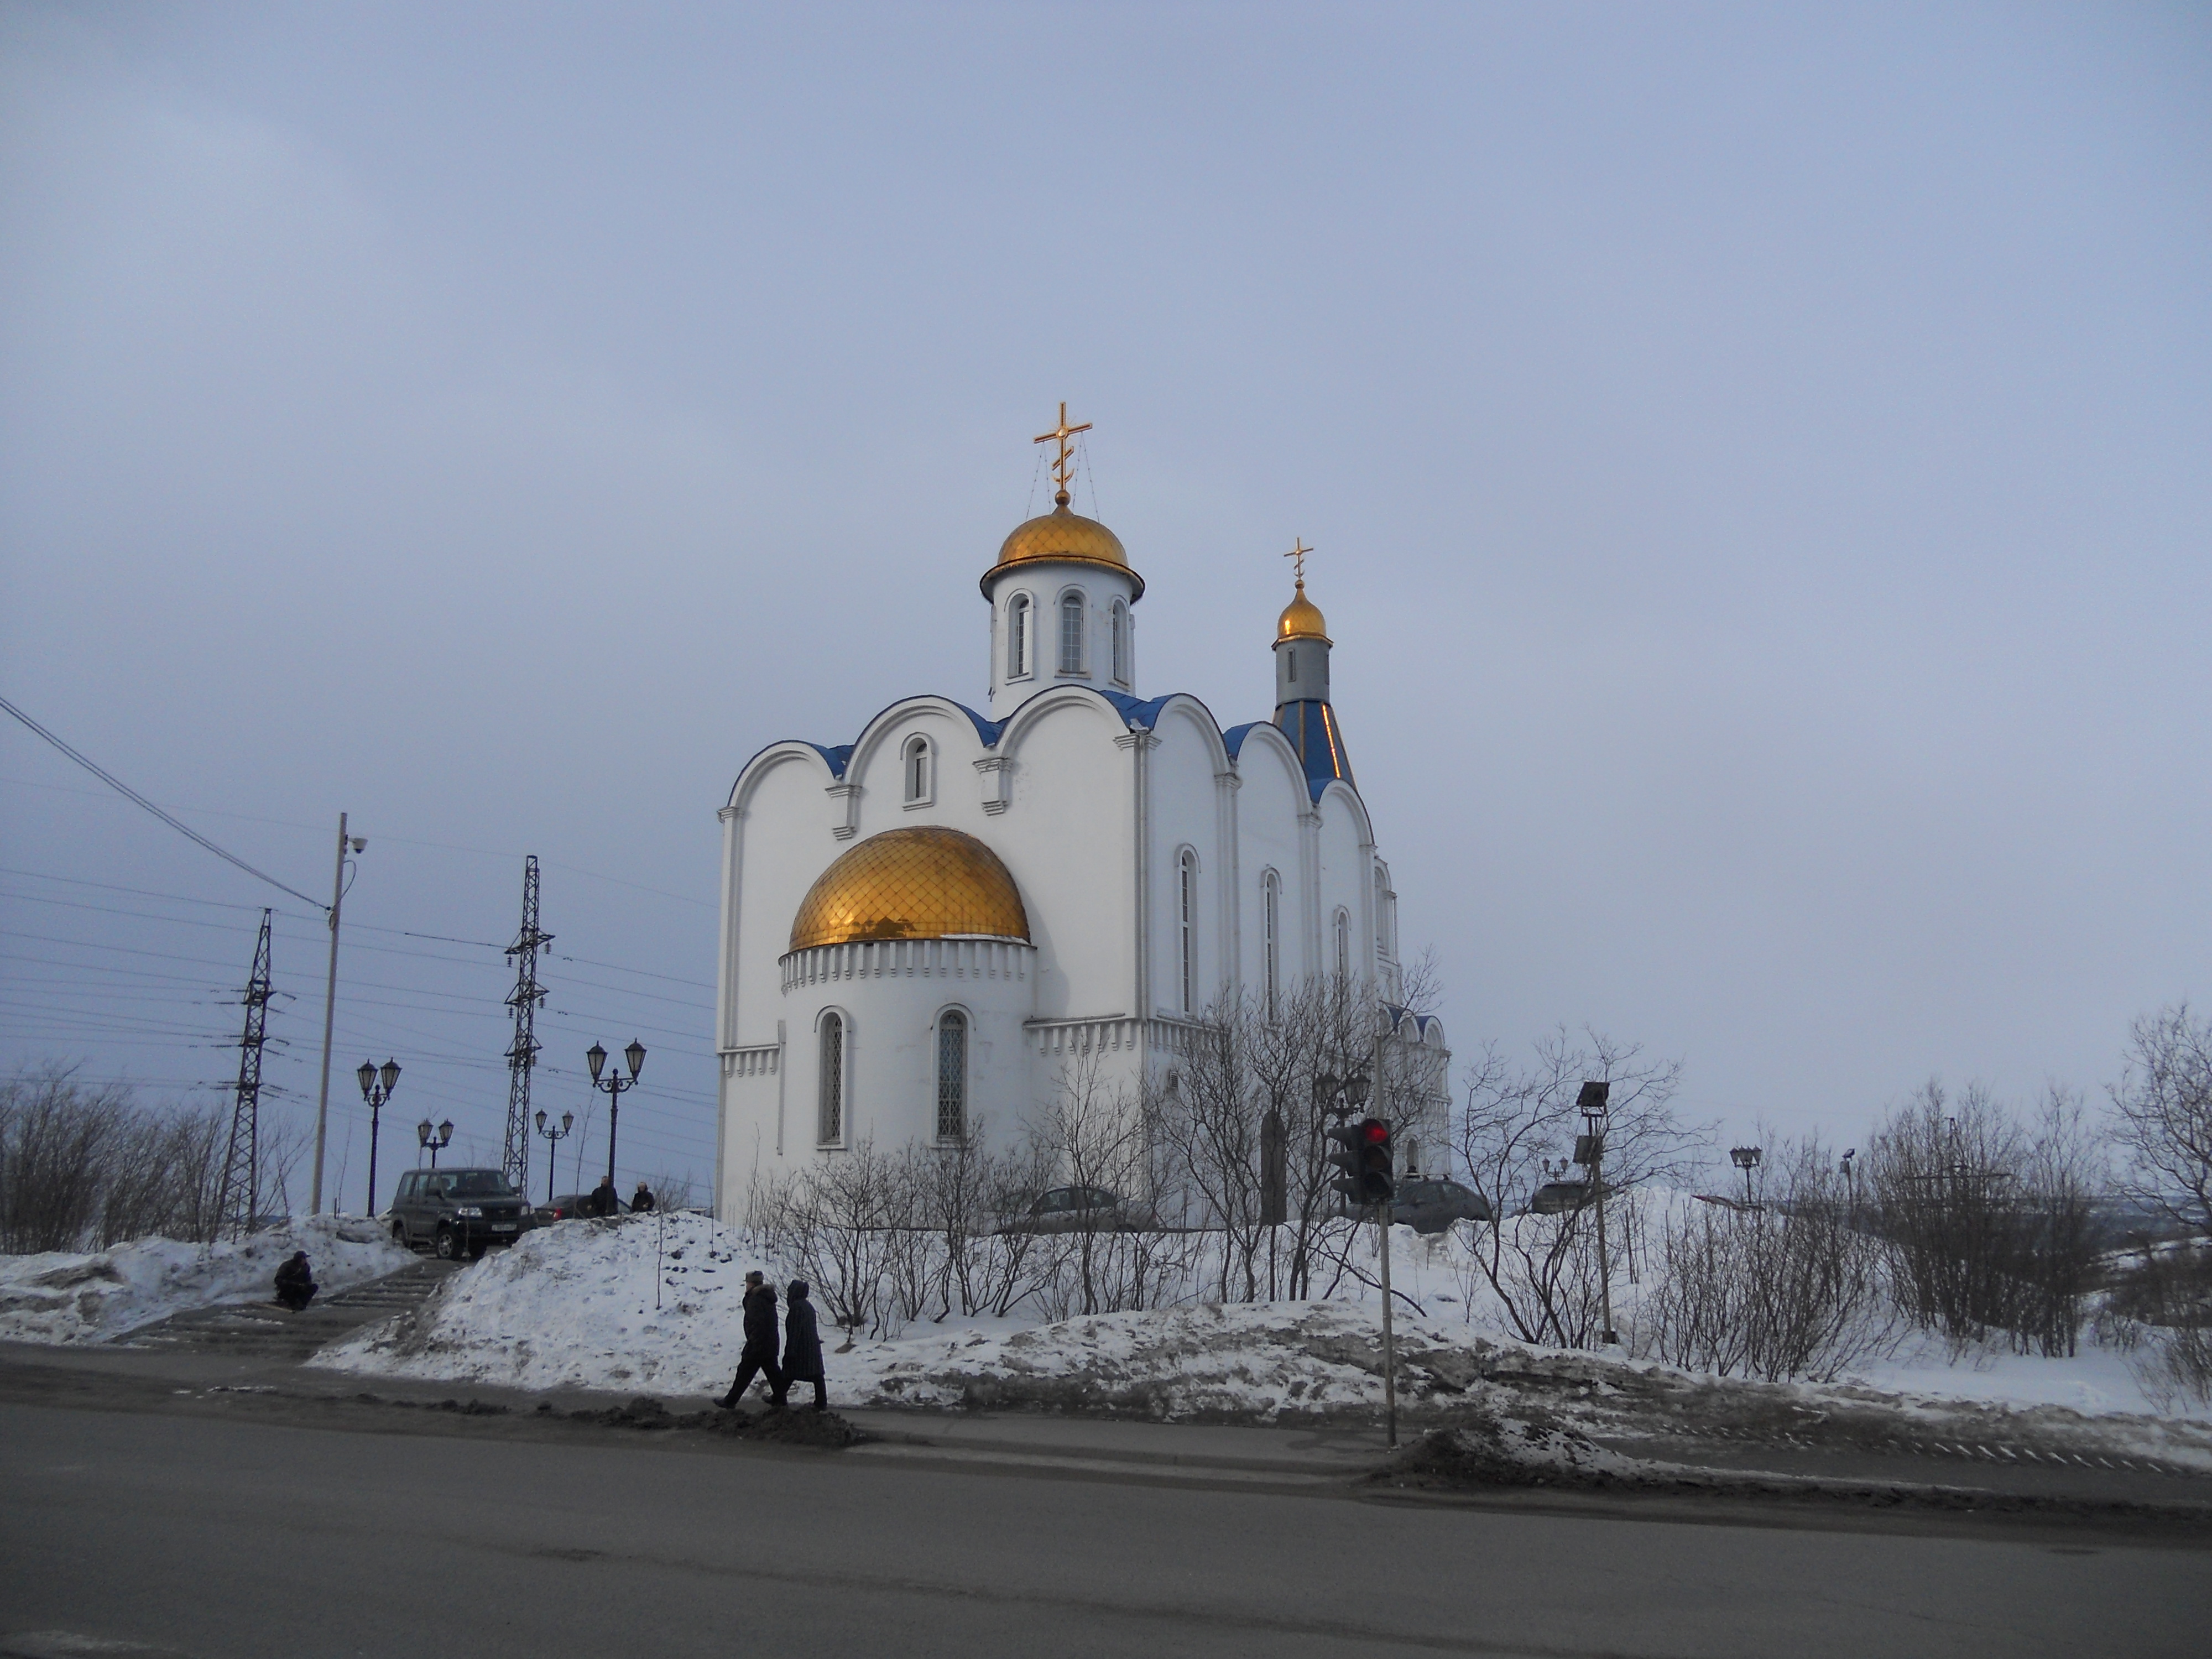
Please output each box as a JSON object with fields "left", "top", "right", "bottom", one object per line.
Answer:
{"left": 314, "top": 1214, "right": 2212, "bottom": 1471}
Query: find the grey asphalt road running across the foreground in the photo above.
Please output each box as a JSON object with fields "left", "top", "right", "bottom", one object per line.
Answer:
{"left": 13, "top": 1405, "right": 2212, "bottom": 1659}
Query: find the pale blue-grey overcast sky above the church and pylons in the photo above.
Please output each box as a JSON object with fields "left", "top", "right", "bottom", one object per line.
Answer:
{"left": 0, "top": 0, "right": 2212, "bottom": 1208}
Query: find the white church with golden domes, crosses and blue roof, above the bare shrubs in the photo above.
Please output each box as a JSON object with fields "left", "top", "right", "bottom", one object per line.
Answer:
{"left": 714, "top": 407, "right": 1449, "bottom": 1214}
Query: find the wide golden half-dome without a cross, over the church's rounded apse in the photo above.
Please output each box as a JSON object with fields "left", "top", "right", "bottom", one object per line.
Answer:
{"left": 792, "top": 825, "right": 1029, "bottom": 951}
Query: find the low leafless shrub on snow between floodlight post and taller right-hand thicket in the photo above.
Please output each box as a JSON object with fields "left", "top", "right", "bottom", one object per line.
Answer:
{"left": 1644, "top": 1137, "right": 1896, "bottom": 1383}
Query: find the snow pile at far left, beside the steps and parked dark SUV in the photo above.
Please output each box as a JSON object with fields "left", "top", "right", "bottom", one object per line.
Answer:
{"left": 0, "top": 1217, "right": 414, "bottom": 1343}
